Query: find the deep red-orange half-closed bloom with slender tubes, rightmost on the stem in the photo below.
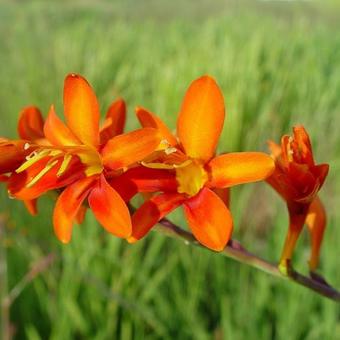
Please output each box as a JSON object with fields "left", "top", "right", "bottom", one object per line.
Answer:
{"left": 267, "top": 126, "right": 329, "bottom": 272}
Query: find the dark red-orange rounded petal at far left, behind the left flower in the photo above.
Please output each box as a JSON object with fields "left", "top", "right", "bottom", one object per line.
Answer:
{"left": 18, "top": 106, "right": 44, "bottom": 140}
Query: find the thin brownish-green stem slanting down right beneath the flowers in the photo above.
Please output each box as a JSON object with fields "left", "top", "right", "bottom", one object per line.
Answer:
{"left": 156, "top": 219, "right": 340, "bottom": 302}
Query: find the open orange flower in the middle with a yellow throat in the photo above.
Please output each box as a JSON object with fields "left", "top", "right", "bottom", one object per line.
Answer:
{"left": 129, "top": 76, "right": 274, "bottom": 251}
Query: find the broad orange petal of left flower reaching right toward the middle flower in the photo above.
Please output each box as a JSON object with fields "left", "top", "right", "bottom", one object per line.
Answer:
{"left": 102, "top": 128, "right": 161, "bottom": 170}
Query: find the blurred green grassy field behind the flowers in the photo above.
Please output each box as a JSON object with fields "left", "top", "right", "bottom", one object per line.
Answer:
{"left": 0, "top": 0, "right": 340, "bottom": 340}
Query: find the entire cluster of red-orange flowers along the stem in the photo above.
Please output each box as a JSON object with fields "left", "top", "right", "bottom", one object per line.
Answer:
{"left": 0, "top": 74, "right": 328, "bottom": 269}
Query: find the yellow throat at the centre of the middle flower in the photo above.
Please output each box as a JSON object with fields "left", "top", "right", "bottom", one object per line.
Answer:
{"left": 176, "top": 160, "right": 208, "bottom": 196}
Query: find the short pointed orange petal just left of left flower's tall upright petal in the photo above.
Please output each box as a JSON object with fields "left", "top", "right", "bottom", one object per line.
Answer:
{"left": 44, "top": 105, "right": 81, "bottom": 146}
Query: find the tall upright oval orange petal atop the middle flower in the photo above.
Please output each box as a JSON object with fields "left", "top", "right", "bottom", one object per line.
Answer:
{"left": 177, "top": 76, "right": 225, "bottom": 161}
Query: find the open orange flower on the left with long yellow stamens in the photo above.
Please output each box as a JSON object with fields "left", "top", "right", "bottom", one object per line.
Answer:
{"left": 9, "top": 74, "right": 161, "bottom": 243}
